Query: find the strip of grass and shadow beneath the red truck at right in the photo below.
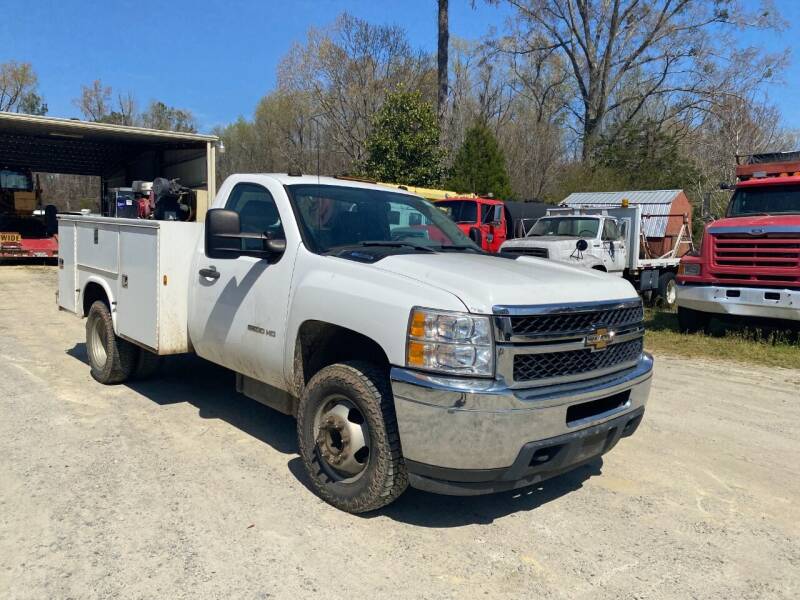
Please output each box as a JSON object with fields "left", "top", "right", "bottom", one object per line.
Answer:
{"left": 644, "top": 310, "right": 800, "bottom": 369}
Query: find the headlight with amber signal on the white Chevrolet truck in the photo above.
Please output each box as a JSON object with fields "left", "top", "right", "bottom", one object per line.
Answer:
{"left": 406, "top": 308, "right": 494, "bottom": 376}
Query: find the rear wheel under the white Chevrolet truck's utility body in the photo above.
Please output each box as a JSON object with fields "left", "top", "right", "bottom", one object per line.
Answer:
{"left": 86, "top": 300, "right": 138, "bottom": 385}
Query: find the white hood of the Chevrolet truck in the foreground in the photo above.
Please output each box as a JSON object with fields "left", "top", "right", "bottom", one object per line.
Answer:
{"left": 374, "top": 253, "right": 636, "bottom": 314}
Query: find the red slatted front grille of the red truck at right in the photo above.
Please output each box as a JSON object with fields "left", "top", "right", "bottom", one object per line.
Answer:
{"left": 710, "top": 234, "right": 800, "bottom": 284}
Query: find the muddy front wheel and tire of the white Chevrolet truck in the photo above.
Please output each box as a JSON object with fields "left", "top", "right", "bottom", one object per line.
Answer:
{"left": 297, "top": 362, "right": 408, "bottom": 513}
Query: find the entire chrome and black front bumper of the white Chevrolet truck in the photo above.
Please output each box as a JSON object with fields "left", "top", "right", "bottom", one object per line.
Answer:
{"left": 391, "top": 354, "right": 653, "bottom": 495}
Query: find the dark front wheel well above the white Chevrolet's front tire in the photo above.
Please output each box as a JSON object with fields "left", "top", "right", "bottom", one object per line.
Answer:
{"left": 294, "top": 321, "right": 389, "bottom": 396}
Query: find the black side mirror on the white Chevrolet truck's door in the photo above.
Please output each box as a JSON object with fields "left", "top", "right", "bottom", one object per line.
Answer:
{"left": 205, "top": 208, "right": 286, "bottom": 258}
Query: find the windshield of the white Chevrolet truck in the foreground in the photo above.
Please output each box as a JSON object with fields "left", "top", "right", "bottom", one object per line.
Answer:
{"left": 287, "top": 185, "right": 480, "bottom": 253}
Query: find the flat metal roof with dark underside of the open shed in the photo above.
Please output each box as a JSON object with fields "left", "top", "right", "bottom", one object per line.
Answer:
{"left": 0, "top": 112, "right": 218, "bottom": 218}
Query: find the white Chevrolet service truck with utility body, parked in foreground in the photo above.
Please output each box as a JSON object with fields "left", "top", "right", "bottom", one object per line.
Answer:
{"left": 58, "top": 175, "right": 653, "bottom": 512}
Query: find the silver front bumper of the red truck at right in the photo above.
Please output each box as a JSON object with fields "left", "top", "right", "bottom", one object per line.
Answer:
{"left": 678, "top": 285, "right": 800, "bottom": 321}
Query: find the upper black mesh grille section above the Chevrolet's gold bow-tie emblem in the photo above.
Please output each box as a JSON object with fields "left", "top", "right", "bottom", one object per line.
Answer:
{"left": 511, "top": 303, "right": 644, "bottom": 336}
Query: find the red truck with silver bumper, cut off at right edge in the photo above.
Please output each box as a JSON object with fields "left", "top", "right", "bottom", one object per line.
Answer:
{"left": 677, "top": 151, "right": 800, "bottom": 332}
